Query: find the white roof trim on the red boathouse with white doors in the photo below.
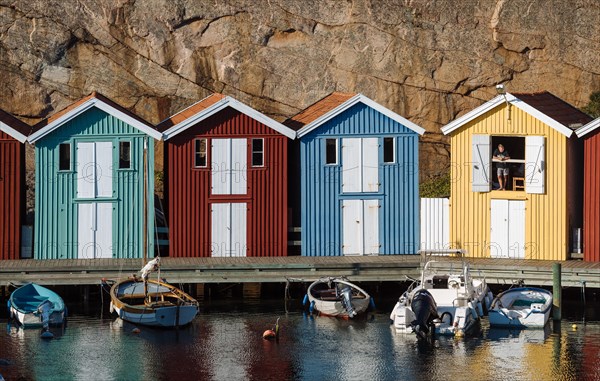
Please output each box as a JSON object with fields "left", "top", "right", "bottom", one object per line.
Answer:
{"left": 163, "top": 96, "right": 296, "bottom": 140}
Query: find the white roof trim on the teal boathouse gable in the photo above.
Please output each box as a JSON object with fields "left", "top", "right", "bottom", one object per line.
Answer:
{"left": 27, "top": 98, "right": 162, "bottom": 143}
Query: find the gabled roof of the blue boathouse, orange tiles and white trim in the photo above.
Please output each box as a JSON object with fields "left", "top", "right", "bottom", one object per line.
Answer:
{"left": 286, "top": 92, "right": 425, "bottom": 138}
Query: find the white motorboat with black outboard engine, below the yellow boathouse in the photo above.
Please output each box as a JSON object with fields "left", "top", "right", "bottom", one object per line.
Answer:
{"left": 390, "top": 261, "right": 493, "bottom": 337}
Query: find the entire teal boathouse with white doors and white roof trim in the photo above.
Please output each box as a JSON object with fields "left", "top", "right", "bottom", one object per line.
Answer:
{"left": 29, "top": 93, "right": 161, "bottom": 259}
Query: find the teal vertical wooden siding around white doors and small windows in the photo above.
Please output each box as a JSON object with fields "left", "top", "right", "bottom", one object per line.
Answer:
{"left": 34, "top": 108, "right": 154, "bottom": 259}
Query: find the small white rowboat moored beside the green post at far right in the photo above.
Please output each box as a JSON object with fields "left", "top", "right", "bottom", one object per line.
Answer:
{"left": 489, "top": 287, "right": 552, "bottom": 328}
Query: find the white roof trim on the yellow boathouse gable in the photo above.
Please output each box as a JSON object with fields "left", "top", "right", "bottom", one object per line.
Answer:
{"left": 442, "top": 93, "right": 573, "bottom": 138}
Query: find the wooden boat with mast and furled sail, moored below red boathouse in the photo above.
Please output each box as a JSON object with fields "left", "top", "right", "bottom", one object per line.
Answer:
{"left": 110, "top": 257, "right": 198, "bottom": 327}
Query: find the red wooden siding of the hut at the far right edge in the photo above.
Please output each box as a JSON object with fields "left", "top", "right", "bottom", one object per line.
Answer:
{"left": 583, "top": 132, "right": 600, "bottom": 262}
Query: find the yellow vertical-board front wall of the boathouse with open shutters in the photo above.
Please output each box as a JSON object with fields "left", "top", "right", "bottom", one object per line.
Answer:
{"left": 450, "top": 104, "right": 569, "bottom": 260}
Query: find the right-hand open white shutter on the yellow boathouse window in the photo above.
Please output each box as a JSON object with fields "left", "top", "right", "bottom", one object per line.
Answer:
{"left": 525, "top": 136, "right": 546, "bottom": 194}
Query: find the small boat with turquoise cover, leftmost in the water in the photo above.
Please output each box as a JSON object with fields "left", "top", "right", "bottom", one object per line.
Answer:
{"left": 8, "top": 283, "right": 66, "bottom": 330}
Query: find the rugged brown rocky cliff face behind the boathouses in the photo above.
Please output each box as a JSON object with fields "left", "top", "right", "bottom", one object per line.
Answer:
{"left": 0, "top": 0, "right": 600, "bottom": 180}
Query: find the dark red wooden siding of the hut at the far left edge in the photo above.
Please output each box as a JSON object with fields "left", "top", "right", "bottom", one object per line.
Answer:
{"left": 0, "top": 131, "right": 25, "bottom": 259}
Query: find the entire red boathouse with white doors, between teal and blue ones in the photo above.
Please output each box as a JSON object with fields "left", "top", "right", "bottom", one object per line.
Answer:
{"left": 158, "top": 94, "right": 296, "bottom": 257}
